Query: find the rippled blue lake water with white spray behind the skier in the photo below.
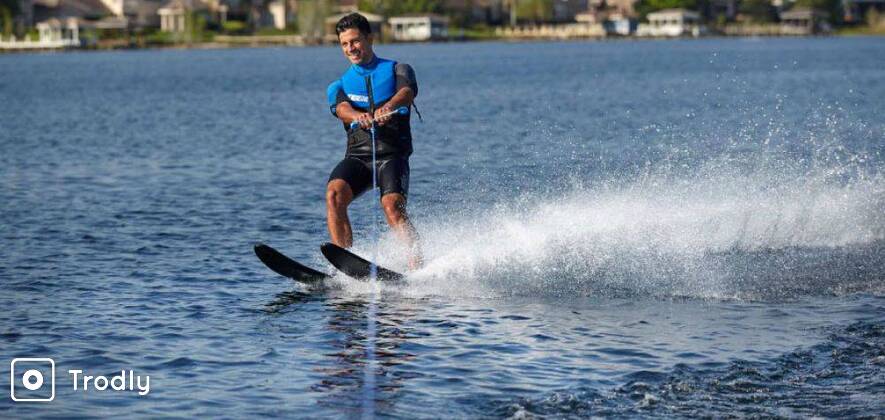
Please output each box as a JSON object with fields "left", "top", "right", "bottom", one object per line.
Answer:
{"left": 0, "top": 38, "right": 885, "bottom": 418}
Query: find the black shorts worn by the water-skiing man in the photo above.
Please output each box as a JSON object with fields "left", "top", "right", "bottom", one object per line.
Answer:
{"left": 329, "top": 156, "right": 409, "bottom": 198}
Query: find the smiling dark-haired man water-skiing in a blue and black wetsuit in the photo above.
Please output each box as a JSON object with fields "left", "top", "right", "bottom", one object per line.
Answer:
{"left": 326, "top": 13, "right": 421, "bottom": 269}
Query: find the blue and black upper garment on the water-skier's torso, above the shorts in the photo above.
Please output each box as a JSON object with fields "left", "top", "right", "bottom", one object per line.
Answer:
{"left": 326, "top": 56, "right": 418, "bottom": 159}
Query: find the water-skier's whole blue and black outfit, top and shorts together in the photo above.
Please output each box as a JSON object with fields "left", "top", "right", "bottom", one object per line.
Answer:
{"left": 327, "top": 56, "right": 418, "bottom": 197}
